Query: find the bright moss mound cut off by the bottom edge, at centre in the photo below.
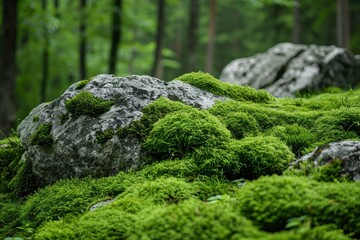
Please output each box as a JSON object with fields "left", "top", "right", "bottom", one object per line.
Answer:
{"left": 128, "top": 200, "right": 262, "bottom": 240}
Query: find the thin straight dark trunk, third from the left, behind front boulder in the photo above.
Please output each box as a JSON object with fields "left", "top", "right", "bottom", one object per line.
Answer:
{"left": 79, "top": 0, "right": 87, "bottom": 79}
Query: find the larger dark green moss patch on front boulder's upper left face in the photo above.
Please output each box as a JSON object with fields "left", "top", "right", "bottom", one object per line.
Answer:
{"left": 65, "top": 92, "right": 114, "bottom": 118}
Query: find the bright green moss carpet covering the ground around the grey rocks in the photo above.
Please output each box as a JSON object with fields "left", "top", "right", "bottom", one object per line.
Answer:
{"left": 0, "top": 72, "right": 360, "bottom": 240}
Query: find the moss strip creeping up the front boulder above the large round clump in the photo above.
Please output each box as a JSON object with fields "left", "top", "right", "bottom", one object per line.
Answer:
{"left": 117, "top": 97, "right": 191, "bottom": 139}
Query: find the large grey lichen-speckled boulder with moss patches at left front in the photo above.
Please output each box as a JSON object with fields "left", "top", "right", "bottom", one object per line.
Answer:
{"left": 18, "top": 74, "right": 225, "bottom": 184}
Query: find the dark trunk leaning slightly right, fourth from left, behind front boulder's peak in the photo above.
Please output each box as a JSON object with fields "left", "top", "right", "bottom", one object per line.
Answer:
{"left": 109, "top": 0, "right": 123, "bottom": 74}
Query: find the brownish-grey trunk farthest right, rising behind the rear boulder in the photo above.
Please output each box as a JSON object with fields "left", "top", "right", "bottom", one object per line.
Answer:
{"left": 336, "top": 0, "right": 350, "bottom": 48}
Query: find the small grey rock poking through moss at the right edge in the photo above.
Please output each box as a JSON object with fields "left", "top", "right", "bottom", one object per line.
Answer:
{"left": 293, "top": 140, "right": 360, "bottom": 181}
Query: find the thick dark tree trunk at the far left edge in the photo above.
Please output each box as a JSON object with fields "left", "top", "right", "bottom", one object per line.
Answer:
{"left": 0, "top": 0, "right": 18, "bottom": 138}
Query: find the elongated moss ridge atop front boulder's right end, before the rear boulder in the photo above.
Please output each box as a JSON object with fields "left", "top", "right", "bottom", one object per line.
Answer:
{"left": 177, "top": 72, "right": 274, "bottom": 103}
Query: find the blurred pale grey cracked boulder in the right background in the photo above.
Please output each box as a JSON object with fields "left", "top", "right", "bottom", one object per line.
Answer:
{"left": 220, "top": 43, "right": 360, "bottom": 97}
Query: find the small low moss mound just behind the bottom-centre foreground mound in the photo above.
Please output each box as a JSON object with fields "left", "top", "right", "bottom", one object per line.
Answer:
{"left": 121, "top": 177, "right": 195, "bottom": 204}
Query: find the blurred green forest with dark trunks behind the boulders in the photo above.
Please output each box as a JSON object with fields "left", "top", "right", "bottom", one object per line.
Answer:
{"left": 0, "top": 0, "right": 360, "bottom": 138}
